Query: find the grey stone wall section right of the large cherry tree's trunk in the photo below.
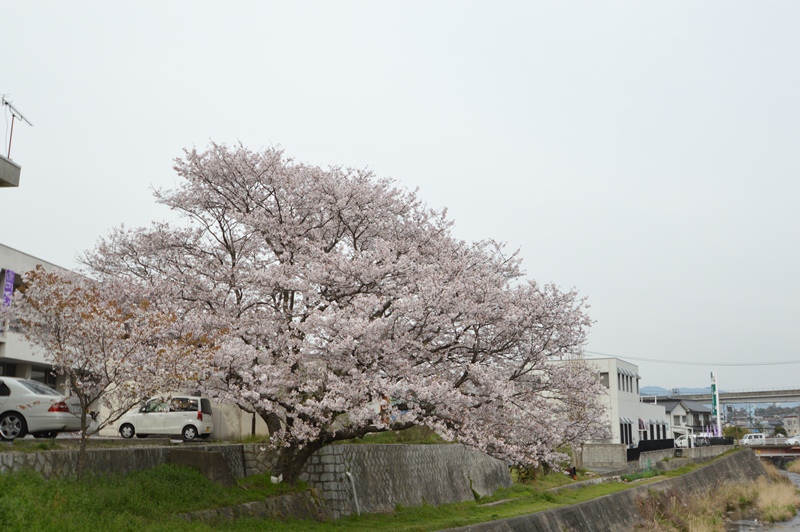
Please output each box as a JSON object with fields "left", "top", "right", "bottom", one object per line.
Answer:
{"left": 301, "top": 444, "right": 511, "bottom": 517}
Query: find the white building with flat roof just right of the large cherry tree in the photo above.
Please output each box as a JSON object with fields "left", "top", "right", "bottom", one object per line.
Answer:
{"left": 586, "top": 358, "right": 673, "bottom": 446}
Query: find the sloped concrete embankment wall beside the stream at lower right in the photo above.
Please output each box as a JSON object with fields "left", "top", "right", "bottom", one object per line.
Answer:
{"left": 452, "top": 450, "right": 767, "bottom": 532}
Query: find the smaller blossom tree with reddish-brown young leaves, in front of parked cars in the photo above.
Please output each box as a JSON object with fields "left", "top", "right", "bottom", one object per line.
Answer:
{"left": 11, "top": 266, "right": 212, "bottom": 476}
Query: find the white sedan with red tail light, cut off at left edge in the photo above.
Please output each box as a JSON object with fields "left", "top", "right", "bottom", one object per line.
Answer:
{"left": 0, "top": 377, "right": 81, "bottom": 440}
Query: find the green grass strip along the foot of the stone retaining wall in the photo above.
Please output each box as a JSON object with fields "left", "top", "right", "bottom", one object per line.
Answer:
{"left": 0, "top": 465, "right": 648, "bottom": 531}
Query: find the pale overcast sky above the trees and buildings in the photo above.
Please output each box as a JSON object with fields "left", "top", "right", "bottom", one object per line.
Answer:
{"left": 0, "top": 0, "right": 800, "bottom": 389}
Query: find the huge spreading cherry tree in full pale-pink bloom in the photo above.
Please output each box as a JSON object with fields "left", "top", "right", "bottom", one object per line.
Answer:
{"left": 84, "top": 144, "right": 605, "bottom": 482}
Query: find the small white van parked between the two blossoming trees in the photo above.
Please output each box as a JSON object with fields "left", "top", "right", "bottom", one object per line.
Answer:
{"left": 119, "top": 394, "right": 214, "bottom": 441}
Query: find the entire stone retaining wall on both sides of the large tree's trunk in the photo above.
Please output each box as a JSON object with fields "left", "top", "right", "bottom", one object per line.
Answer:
{"left": 0, "top": 444, "right": 511, "bottom": 517}
